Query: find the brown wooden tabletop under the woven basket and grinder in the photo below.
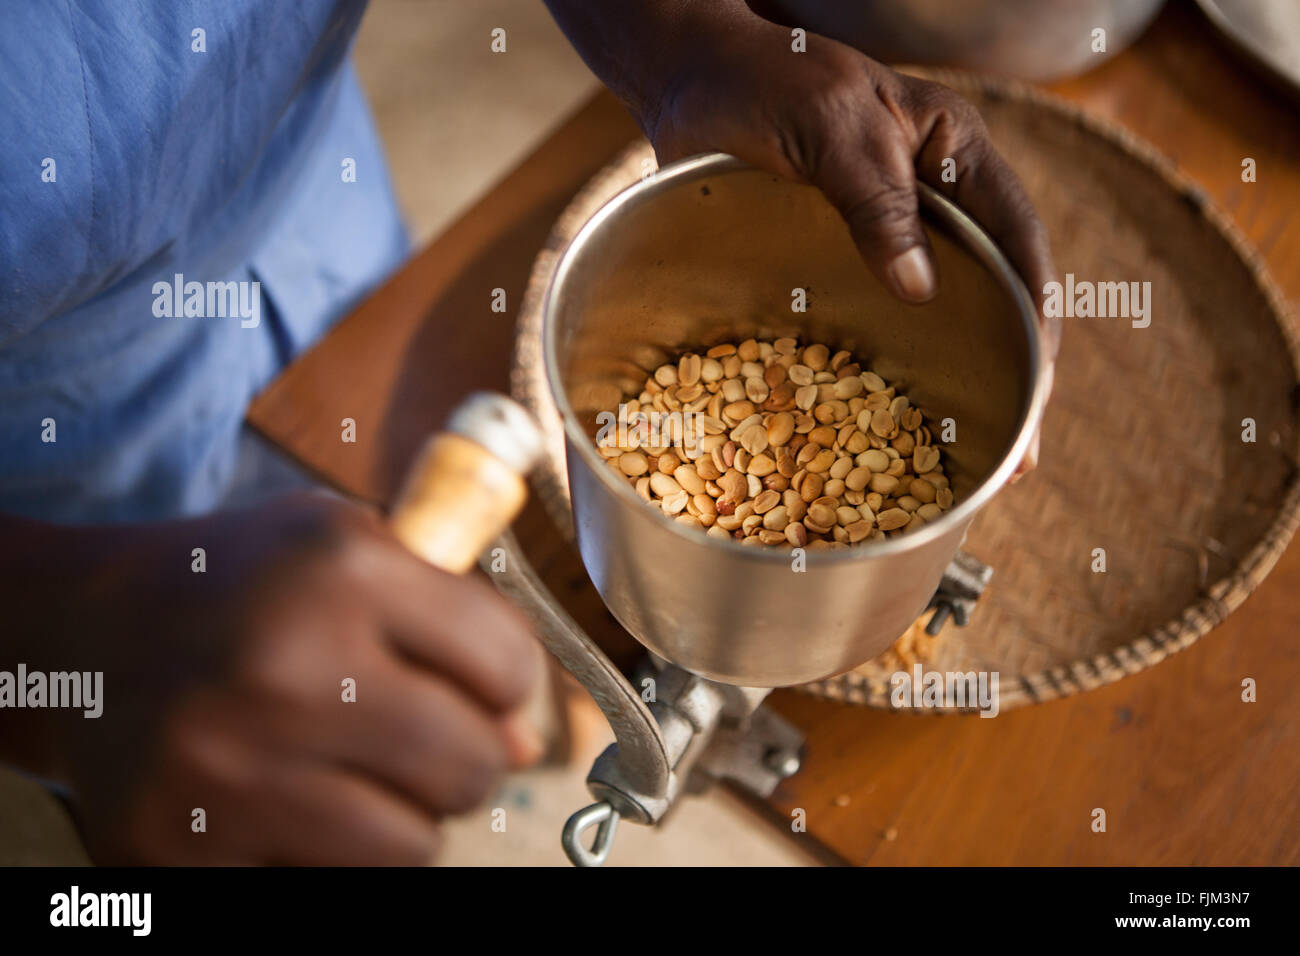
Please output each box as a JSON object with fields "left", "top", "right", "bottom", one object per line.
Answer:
{"left": 250, "top": 3, "right": 1300, "bottom": 865}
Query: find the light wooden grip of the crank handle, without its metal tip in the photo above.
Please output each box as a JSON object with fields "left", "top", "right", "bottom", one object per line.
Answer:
{"left": 390, "top": 432, "right": 528, "bottom": 574}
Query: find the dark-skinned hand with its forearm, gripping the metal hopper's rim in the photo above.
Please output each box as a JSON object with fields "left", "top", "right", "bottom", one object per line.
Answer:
{"left": 547, "top": 0, "right": 1060, "bottom": 467}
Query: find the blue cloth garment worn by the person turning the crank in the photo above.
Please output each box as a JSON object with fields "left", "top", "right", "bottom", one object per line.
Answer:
{"left": 0, "top": 0, "right": 408, "bottom": 522}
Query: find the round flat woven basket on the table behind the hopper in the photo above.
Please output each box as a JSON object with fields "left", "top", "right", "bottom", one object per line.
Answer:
{"left": 515, "top": 70, "right": 1300, "bottom": 713}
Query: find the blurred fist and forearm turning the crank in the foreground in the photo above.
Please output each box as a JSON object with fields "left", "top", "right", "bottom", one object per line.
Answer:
{"left": 3, "top": 494, "right": 540, "bottom": 864}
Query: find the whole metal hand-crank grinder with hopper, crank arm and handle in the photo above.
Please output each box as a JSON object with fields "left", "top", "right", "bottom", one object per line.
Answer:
{"left": 394, "top": 153, "right": 1048, "bottom": 866}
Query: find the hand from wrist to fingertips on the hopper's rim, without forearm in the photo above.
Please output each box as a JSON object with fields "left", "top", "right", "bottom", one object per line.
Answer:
{"left": 642, "top": 32, "right": 1052, "bottom": 302}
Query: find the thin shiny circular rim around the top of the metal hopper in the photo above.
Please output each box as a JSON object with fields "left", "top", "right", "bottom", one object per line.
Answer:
{"left": 541, "top": 152, "right": 1048, "bottom": 564}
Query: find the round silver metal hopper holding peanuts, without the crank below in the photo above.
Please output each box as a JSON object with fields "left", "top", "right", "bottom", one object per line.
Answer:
{"left": 542, "top": 153, "right": 1047, "bottom": 687}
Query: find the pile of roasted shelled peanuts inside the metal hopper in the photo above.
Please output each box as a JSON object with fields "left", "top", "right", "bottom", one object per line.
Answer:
{"left": 597, "top": 338, "right": 953, "bottom": 550}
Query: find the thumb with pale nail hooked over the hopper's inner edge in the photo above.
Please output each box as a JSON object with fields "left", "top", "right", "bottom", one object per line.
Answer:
{"left": 809, "top": 133, "right": 939, "bottom": 302}
